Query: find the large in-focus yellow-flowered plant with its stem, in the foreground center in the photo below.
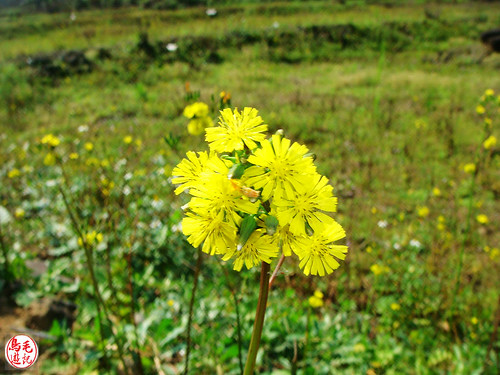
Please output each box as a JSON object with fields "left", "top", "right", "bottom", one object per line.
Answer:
{"left": 172, "top": 107, "right": 347, "bottom": 374}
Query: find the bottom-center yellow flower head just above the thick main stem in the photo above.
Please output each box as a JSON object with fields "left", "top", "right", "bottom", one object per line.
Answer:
{"left": 222, "top": 229, "right": 279, "bottom": 271}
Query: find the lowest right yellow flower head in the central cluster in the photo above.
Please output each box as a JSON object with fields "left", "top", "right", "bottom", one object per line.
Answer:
{"left": 293, "top": 221, "right": 347, "bottom": 276}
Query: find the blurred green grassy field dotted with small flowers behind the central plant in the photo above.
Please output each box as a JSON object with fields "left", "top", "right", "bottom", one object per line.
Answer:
{"left": 0, "top": 1, "right": 500, "bottom": 375}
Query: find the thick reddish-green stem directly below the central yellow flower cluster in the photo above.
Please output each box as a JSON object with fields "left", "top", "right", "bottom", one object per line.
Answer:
{"left": 243, "top": 262, "right": 271, "bottom": 375}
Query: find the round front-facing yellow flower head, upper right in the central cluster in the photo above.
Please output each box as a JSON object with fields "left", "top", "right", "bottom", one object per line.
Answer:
{"left": 242, "top": 134, "right": 316, "bottom": 200}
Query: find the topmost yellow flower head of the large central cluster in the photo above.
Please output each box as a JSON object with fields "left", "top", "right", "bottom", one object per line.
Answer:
{"left": 205, "top": 107, "right": 267, "bottom": 152}
